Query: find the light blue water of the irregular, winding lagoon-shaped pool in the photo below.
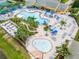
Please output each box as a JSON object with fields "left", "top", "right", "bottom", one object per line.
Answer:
{"left": 18, "top": 11, "right": 48, "bottom": 25}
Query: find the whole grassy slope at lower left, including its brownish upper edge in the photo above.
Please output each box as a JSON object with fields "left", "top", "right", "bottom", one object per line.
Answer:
{"left": 0, "top": 28, "right": 30, "bottom": 59}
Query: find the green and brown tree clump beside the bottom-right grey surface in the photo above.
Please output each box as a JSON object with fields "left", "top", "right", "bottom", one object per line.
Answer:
{"left": 55, "top": 40, "right": 70, "bottom": 59}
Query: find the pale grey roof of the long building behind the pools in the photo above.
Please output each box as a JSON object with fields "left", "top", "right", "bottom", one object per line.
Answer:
{"left": 27, "top": 0, "right": 68, "bottom": 11}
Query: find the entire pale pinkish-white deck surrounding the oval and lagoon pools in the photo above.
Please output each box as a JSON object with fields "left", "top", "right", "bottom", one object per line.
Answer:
{"left": 1, "top": 8, "right": 78, "bottom": 59}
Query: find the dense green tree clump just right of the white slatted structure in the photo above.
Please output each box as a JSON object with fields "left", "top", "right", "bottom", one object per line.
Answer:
{"left": 15, "top": 24, "right": 34, "bottom": 42}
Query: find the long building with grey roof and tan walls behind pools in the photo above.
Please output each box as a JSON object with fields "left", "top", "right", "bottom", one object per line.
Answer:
{"left": 26, "top": 0, "right": 68, "bottom": 13}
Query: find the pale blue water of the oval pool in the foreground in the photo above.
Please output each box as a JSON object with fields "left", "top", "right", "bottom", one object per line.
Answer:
{"left": 33, "top": 39, "right": 52, "bottom": 53}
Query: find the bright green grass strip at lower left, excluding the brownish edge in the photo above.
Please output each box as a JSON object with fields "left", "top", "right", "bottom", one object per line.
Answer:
{"left": 0, "top": 38, "right": 24, "bottom": 59}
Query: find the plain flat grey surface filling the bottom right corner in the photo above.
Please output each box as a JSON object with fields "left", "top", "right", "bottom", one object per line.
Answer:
{"left": 65, "top": 41, "right": 79, "bottom": 59}
